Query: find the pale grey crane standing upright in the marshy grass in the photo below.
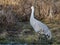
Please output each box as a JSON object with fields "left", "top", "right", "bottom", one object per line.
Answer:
{"left": 30, "top": 6, "right": 52, "bottom": 39}
